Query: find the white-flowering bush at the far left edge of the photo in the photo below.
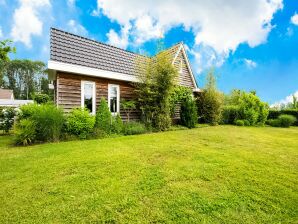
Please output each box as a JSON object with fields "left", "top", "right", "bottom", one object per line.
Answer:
{"left": 0, "top": 107, "right": 20, "bottom": 133}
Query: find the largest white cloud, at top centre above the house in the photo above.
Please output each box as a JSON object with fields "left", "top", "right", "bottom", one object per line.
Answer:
{"left": 96, "top": 0, "right": 283, "bottom": 72}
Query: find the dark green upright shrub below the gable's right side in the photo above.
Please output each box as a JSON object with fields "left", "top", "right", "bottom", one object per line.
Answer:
{"left": 180, "top": 98, "right": 198, "bottom": 128}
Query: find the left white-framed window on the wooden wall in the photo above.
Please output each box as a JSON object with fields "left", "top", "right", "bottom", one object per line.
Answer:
{"left": 81, "top": 81, "right": 96, "bottom": 114}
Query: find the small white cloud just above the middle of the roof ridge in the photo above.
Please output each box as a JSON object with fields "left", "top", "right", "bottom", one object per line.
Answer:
{"left": 107, "top": 25, "right": 130, "bottom": 49}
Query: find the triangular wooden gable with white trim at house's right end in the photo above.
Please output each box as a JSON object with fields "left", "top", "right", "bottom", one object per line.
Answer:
{"left": 172, "top": 43, "right": 198, "bottom": 89}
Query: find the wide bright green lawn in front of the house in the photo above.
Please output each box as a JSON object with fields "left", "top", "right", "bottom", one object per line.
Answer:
{"left": 0, "top": 126, "right": 298, "bottom": 223}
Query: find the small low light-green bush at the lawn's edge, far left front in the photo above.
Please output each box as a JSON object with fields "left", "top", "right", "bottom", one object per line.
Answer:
{"left": 15, "top": 119, "right": 36, "bottom": 145}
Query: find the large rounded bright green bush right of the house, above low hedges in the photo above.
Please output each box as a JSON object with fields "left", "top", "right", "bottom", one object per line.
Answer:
{"left": 223, "top": 90, "right": 269, "bottom": 125}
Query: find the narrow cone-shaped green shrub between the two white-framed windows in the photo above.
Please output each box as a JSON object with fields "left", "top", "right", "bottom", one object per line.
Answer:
{"left": 95, "top": 98, "right": 112, "bottom": 134}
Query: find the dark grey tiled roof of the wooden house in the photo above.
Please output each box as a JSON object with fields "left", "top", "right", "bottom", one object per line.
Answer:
{"left": 50, "top": 28, "right": 178, "bottom": 75}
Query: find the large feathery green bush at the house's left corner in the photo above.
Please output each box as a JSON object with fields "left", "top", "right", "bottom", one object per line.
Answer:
{"left": 19, "top": 103, "right": 64, "bottom": 142}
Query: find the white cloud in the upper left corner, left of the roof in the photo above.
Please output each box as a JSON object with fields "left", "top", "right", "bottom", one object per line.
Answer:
{"left": 11, "top": 0, "right": 51, "bottom": 47}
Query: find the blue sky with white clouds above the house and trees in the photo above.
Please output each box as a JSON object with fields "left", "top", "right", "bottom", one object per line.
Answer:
{"left": 0, "top": 0, "right": 298, "bottom": 104}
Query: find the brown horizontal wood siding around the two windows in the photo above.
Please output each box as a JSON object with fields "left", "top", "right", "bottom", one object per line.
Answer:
{"left": 57, "top": 72, "right": 140, "bottom": 120}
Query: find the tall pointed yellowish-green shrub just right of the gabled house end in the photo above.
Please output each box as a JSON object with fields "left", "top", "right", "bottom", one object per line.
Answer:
{"left": 197, "top": 70, "right": 224, "bottom": 125}
